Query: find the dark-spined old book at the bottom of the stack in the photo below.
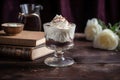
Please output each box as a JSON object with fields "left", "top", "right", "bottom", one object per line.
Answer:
{"left": 0, "top": 45, "right": 54, "bottom": 60}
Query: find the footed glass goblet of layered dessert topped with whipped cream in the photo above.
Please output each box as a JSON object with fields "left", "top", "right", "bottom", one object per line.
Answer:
{"left": 43, "top": 15, "right": 76, "bottom": 67}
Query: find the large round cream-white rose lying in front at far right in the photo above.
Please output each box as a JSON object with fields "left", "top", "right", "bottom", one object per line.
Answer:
{"left": 93, "top": 29, "right": 119, "bottom": 50}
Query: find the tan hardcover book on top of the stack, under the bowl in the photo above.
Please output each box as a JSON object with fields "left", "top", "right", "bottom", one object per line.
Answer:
{"left": 0, "top": 31, "right": 45, "bottom": 46}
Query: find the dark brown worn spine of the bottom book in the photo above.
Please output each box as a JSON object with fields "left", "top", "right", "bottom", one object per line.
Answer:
{"left": 0, "top": 46, "right": 32, "bottom": 60}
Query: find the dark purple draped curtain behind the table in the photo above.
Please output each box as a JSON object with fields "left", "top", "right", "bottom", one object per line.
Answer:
{"left": 0, "top": 0, "right": 120, "bottom": 32}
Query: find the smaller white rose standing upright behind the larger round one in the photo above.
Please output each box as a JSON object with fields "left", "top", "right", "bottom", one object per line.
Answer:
{"left": 85, "top": 18, "right": 102, "bottom": 40}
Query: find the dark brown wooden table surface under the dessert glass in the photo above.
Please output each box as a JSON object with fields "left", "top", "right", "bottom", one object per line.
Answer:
{"left": 0, "top": 34, "right": 120, "bottom": 80}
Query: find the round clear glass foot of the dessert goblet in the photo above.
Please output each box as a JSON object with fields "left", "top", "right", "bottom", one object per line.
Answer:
{"left": 44, "top": 57, "right": 74, "bottom": 67}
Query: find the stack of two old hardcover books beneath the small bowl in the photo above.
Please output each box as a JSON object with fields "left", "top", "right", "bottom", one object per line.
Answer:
{"left": 0, "top": 31, "right": 54, "bottom": 60}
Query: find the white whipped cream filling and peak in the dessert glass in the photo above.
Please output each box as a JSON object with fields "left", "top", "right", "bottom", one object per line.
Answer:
{"left": 43, "top": 15, "right": 76, "bottom": 42}
